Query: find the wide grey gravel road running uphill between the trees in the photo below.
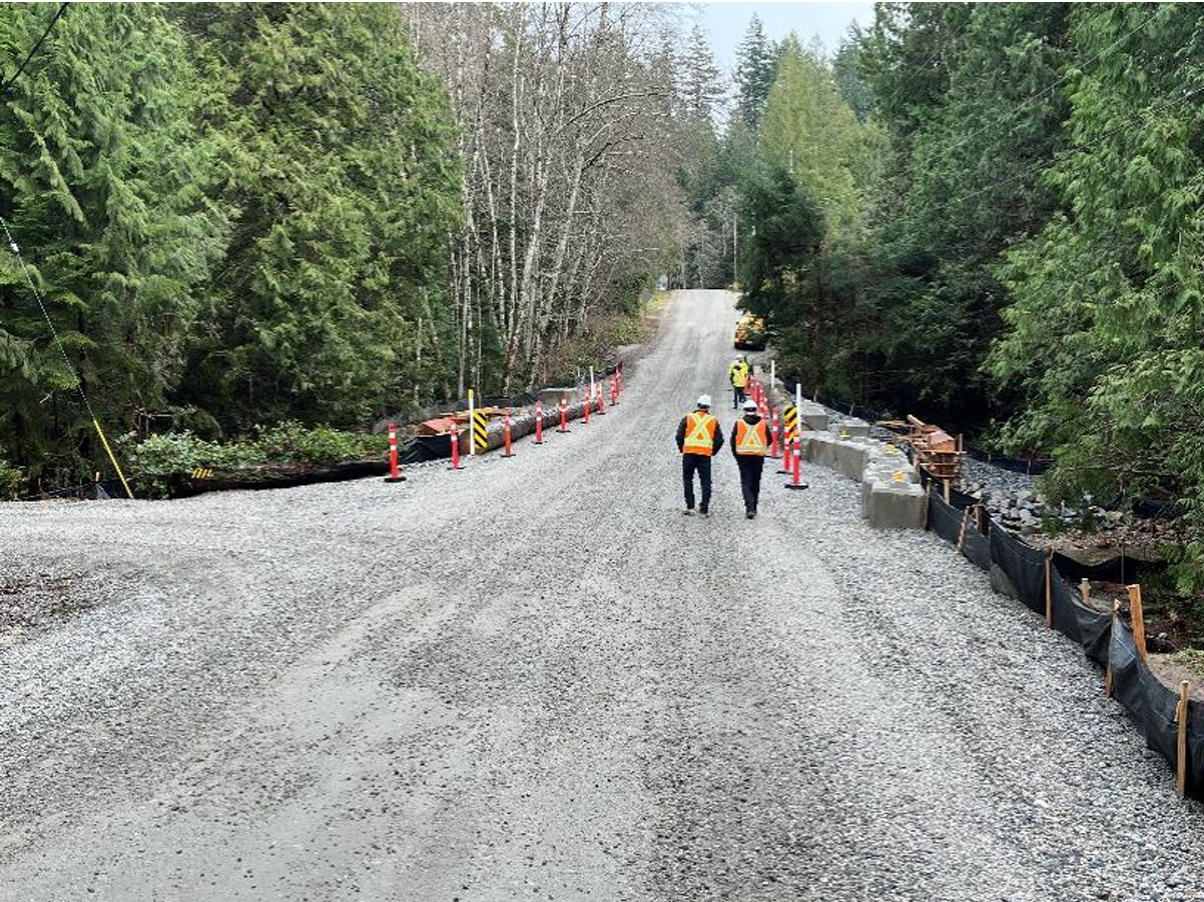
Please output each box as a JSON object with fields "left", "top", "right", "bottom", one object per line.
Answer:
{"left": 0, "top": 291, "right": 1204, "bottom": 902}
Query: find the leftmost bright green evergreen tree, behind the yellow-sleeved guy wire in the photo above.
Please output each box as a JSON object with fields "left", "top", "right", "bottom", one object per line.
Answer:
{"left": 0, "top": 4, "right": 226, "bottom": 478}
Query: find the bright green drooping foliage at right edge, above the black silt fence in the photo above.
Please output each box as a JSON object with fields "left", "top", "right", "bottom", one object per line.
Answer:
{"left": 988, "top": 5, "right": 1204, "bottom": 591}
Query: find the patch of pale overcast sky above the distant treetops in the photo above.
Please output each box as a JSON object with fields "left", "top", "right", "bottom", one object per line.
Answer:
{"left": 695, "top": 2, "right": 874, "bottom": 75}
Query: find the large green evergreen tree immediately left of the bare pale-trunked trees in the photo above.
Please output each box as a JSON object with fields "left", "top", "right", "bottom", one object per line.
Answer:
{"left": 179, "top": 4, "right": 459, "bottom": 426}
